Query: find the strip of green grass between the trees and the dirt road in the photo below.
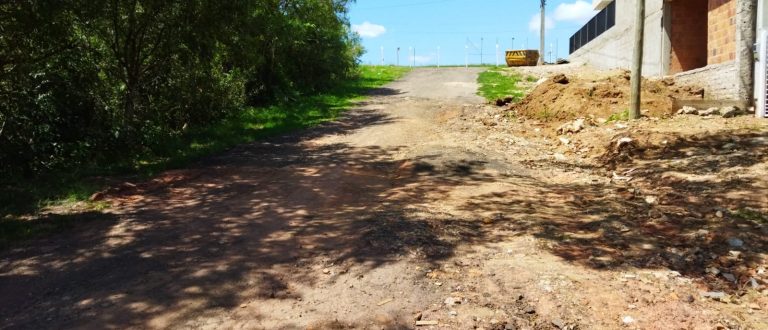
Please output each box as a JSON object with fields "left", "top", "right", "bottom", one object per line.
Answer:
{"left": 0, "top": 66, "right": 409, "bottom": 248}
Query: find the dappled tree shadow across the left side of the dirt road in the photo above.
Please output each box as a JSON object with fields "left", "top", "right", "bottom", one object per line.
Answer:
{"left": 0, "top": 94, "right": 504, "bottom": 328}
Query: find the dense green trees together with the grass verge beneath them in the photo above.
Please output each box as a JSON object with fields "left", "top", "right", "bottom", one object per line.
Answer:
{"left": 0, "top": 0, "right": 412, "bottom": 243}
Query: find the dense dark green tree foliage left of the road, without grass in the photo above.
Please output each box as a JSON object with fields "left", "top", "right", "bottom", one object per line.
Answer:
{"left": 0, "top": 0, "right": 361, "bottom": 179}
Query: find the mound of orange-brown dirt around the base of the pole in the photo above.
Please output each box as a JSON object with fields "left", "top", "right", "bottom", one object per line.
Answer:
{"left": 510, "top": 71, "right": 703, "bottom": 123}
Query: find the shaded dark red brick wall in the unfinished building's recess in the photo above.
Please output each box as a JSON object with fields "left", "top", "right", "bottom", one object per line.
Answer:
{"left": 668, "top": 0, "right": 712, "bottom": 74}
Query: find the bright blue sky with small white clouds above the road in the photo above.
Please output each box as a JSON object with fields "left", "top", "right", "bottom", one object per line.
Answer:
{"left": 349, "top": 0, "right": 596, "bottom": 65}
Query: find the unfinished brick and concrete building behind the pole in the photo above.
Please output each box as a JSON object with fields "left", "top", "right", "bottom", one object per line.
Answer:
{"left": 570, "top": 0, "right": 764, "bottom": 108}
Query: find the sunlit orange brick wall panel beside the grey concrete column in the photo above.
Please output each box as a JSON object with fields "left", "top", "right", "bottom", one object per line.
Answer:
{"left": 707, "top": 0, "right": 737, "bottom": 64}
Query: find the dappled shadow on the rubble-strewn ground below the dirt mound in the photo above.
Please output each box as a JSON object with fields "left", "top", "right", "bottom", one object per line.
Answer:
{"left": 463, "top": 132, "right": 768, "bottom": 292}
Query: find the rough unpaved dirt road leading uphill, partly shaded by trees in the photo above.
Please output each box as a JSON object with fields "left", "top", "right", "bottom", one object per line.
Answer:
{"left": 0, "top": 69, "right": 766, "bottom": 329}
